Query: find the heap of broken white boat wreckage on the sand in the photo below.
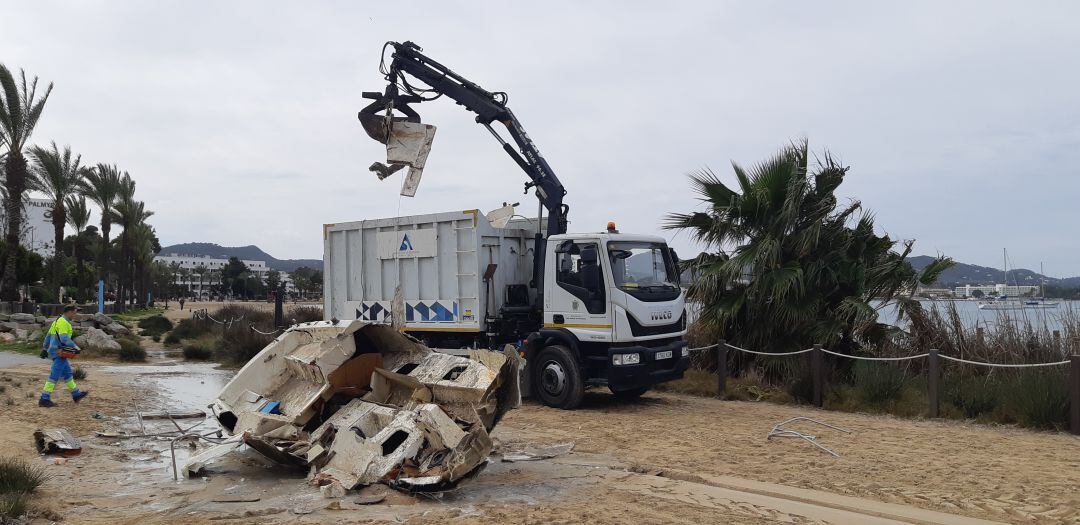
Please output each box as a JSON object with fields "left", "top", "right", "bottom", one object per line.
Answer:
{"left": 185, "top": 321, "right": 521, "bottom": 494}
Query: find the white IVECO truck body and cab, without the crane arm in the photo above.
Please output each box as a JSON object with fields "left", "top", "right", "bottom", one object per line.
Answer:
{"left": 323, "top": 210, "right": 688, "bottom": 408}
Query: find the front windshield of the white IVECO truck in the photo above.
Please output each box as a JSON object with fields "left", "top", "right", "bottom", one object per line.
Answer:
{"left": 608, "top": 241, "right": 678, "bottom": 292}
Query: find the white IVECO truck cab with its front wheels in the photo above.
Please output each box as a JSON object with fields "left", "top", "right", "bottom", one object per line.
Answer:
{"left": 526, "top": 225, "right": 689, "bottom": 408}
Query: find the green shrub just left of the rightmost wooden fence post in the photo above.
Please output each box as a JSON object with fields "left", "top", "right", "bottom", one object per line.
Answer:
{"left": 1002, "top": 368, "right": 1069, "bottom": 429}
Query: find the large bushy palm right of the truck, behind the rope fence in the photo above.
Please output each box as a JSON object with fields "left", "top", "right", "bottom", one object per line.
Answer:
{"left": 666, "top": 142, "right": 951, "bottom": 352}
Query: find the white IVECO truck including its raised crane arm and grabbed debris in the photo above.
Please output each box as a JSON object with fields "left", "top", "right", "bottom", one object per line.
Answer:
{"left": 339, "top": 42, "right": 689, "bottom": 408}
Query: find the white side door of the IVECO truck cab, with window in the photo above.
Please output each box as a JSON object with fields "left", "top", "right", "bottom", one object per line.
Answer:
{"left": 544, "top": 240, "right": 611, "bottom": 341}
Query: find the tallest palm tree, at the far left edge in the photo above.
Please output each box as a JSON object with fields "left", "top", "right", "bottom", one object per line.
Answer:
{"left": 0, "top": 64, "right": 53, "bottom": 300}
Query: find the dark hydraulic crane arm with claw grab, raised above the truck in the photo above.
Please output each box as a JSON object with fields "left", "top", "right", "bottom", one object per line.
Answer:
{"left": 357, "top": 42, "right": 569, "bottom": 237}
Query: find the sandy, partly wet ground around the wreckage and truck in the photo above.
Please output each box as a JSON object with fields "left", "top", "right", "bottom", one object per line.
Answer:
{"left": 0, "top": 355, "right": 1080, "bottom": 525}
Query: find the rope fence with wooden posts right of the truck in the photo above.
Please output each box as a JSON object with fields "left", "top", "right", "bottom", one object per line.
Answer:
{"left": 687, "top": 339, "right": 1080, "bottom": 435}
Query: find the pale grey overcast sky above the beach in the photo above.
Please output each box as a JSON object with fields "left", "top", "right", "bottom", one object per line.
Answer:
{"left": 0, "top": 0, "right": 1080, "bottom": 277}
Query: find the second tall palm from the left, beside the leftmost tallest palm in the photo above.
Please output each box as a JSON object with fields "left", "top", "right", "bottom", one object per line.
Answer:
{"left": 29, "top": 143, "right": 85, "bottom": 286}
